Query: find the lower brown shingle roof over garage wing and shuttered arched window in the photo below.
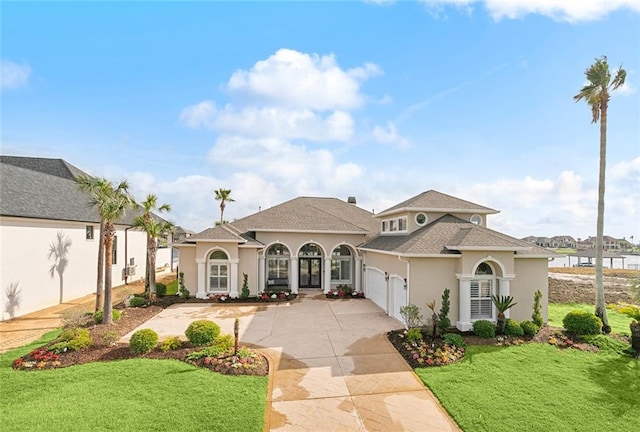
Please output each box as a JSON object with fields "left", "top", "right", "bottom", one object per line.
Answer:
{"left": 361, "top": 214, "right": 552, "bottom": 256}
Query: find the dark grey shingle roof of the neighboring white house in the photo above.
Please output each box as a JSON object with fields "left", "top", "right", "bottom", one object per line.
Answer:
{"left": 0, "top": 156, "right": 163, "bottom": 225}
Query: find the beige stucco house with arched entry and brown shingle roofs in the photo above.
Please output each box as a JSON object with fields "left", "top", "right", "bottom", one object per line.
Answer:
{"left": 174, "top": 190, "right": 553, "bottom": 330}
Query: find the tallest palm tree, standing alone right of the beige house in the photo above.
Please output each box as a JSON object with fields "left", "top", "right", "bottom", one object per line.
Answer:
{"left": 573, "top": 56, "right": 627, "bottom": 333}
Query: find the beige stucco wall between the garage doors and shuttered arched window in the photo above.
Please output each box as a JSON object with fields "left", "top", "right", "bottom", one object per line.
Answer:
{"left": 408, "top": 258, "right": 460, "bottom": 325}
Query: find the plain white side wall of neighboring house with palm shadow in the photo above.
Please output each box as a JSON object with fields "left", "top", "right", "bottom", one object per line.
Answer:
{"left": 0, "top": 217, "right": 146, "bottom": 320}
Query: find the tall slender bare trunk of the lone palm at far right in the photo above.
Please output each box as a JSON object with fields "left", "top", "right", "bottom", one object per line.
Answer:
{"left": 596, "top": 99, "right": 611, "bottom": 334}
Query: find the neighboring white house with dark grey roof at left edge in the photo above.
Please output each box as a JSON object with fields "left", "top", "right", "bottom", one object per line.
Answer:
{"left": 0, "top": 156, "right": 171, "bottom": 320}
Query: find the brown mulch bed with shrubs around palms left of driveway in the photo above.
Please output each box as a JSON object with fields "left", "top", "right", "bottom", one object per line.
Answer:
{"left": 13, "top": 304, "right": 269, "bottom": 376}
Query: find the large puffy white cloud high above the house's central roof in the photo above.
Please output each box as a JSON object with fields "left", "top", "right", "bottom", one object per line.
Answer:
{"left": 227, "top": 49, "right": 381, "bottom": 111}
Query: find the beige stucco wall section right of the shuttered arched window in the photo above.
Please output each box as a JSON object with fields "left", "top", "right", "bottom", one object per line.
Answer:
{"left": 510, "top": 258, "right": 549, "bottom": 322}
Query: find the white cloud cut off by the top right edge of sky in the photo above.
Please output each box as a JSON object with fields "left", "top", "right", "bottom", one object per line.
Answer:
{"left": 422, "top": 0, "right": 640, "bottom": 23}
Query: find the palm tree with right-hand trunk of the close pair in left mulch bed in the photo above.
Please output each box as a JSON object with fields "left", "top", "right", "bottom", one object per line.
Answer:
{"left": 77, "top": 176, "right": 135, "bottom": 324}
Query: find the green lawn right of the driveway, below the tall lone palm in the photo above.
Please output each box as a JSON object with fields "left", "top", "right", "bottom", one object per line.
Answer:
{"left": 416, "top": 344, "right": 640, "bottom": 432}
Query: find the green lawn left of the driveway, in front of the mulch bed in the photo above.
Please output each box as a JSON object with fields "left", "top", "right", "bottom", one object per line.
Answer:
{"left": 0, "top": 333, "right": 267, "bottom": 432}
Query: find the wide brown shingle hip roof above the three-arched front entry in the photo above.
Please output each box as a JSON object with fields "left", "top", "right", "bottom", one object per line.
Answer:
{"left": 230, "top": 197, "right": 379, "bottom": 234}
